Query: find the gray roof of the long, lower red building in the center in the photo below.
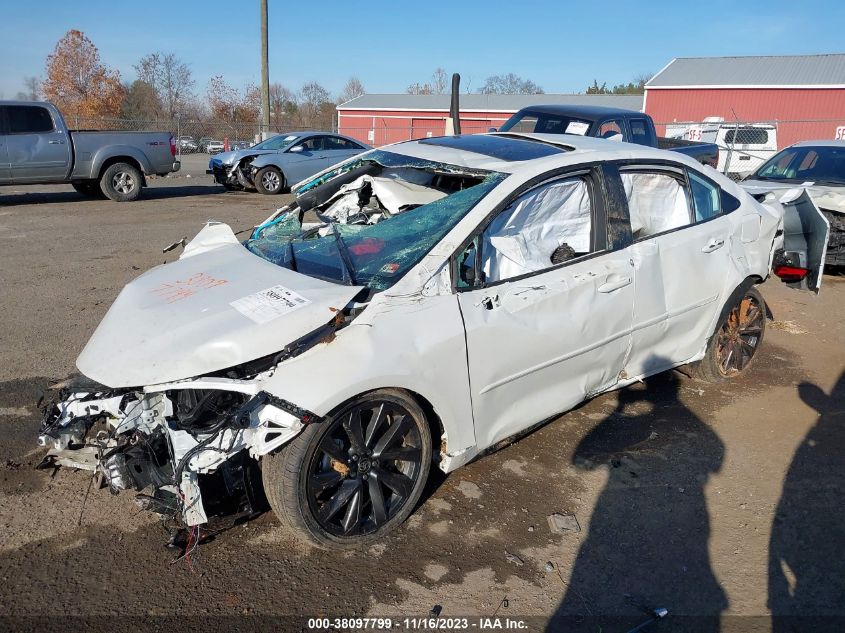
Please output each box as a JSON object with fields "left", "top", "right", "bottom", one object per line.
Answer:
{"left": 337, "top": 94, "right": 643, "bottom": 112}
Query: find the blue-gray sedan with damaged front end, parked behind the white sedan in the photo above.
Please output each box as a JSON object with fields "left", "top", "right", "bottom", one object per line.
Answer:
{"left": 206, "top": 132, "right": 370, "bottom": 195}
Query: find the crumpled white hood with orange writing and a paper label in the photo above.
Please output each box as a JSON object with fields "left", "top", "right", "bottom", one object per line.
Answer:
{"left": 76, "top": 224, "right": 361, "bottom": 388}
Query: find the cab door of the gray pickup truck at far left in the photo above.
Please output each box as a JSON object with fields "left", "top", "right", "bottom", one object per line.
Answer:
{"left": 6, "top": 105, "right": 71, "bottom": 182}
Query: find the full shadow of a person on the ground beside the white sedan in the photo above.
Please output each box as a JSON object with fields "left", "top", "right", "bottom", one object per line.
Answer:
{"left": 546, "top": 372, "right": 728, "bottom": 632}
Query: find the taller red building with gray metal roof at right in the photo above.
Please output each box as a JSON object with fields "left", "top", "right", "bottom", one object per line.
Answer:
{"left": 645, "top": 54, "right": 845, "bottom": 148}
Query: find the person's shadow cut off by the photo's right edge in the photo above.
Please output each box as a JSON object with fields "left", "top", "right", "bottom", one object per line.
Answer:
{"left": 768, "top": 372, "right": 845, "bottom": 633}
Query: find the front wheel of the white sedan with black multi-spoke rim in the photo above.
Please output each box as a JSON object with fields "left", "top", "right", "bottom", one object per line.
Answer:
{"left": 261, "top": 389, "right": 432, "bottom": 548}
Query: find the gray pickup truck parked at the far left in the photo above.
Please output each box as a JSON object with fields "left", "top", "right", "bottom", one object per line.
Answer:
{"left": 0, "top": 101, "right": 179, "bottom": 202}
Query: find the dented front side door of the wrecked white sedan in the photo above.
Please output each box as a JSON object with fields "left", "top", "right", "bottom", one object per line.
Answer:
{"left": 453, "top": 167, "right": 634, "bottom": 448}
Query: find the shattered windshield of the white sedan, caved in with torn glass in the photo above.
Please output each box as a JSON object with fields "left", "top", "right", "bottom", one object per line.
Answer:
{"left": 244, "top": 150, "right": 506, "bottom": 290}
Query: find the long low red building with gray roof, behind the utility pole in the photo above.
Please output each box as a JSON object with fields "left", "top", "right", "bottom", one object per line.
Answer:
{"left": 337, "top": 94, "right": 643, "bottom": 145}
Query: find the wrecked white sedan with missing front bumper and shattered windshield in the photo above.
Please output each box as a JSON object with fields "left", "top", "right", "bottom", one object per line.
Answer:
{"left": 40, "top": 134, "right": 826, "bottom": 546}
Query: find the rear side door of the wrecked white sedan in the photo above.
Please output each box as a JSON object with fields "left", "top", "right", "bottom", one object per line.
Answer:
{"left": 620, "top": 163, "right": 742, "bottom": 379}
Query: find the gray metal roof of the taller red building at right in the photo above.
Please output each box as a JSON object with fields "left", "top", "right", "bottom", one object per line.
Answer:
{"left": 646, "top": 54, "right": 845, "bottom": 89}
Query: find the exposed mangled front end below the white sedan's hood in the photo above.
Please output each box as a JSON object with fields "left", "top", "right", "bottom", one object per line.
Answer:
{"left": 38, "top": 378, "right": 318, "bottom": 526}
